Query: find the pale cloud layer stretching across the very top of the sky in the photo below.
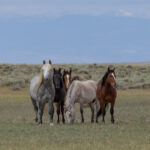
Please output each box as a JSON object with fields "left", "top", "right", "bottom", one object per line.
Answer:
{"left": 0, "top": 0, "right": 150, "bottom": 18}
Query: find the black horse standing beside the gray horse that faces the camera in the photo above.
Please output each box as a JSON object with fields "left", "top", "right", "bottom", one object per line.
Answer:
{"left": 53, "top": 68, "right": 66, "bottom": 123}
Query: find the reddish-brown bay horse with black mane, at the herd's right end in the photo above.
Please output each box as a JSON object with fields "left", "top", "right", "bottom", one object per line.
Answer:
{"left": 96, "top": 67, "right": 117, "bottom": 123}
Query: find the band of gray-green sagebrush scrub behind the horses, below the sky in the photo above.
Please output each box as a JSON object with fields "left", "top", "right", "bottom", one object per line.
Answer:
{"left": 0, "top": 63, "right": 150, "bottom": 90}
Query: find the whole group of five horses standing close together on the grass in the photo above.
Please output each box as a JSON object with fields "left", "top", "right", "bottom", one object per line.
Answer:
{"left": 30, "top": 60, "right": 117, "bottom": 125}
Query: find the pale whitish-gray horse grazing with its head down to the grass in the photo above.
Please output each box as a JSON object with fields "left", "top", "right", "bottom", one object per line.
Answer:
{"left": 65, "top": 80, "right": 99, "bottom": 123}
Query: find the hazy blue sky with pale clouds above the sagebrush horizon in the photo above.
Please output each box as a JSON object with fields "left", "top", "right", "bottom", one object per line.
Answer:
{"left": 0, "top": 0, "right": 150, "bottom": 64}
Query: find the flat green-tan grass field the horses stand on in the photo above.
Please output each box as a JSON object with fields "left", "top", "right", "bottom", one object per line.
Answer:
{"left": 0, "top": 87, "right": 150, "bottom": 150}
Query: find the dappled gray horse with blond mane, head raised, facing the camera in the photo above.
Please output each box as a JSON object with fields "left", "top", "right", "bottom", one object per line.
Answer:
{"left": 30, "top": 61, "right": 55, "bottom": 125}
